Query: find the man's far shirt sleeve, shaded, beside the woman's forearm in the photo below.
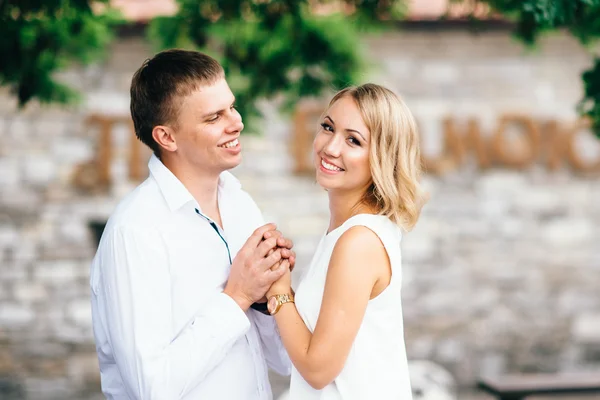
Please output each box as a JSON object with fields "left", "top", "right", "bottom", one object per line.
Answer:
{"left": 250, "top": 310, "right": 292, "bottom": 376}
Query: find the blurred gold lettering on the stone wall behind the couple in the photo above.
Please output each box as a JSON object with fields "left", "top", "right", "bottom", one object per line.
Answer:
{"left": 73, "top": 105, "right": 600, "bottom": 192}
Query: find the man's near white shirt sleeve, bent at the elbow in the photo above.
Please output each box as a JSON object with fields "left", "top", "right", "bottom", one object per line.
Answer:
{"left": 98, "top": 228, "right": 250, "bottom": 400}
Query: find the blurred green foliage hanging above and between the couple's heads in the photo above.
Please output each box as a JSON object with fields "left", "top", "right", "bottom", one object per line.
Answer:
{"left": 149, "top": 0, "right": 404, "bottom": 130}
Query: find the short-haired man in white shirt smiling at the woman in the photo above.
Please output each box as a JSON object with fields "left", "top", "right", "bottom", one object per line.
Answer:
{"left": 90, "top": 50, "right": 294, "bottom": 400}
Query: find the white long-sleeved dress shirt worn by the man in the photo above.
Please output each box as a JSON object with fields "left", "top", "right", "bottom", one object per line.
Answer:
{"left": 90, "top": 156, "right": 291, "bottom": 400}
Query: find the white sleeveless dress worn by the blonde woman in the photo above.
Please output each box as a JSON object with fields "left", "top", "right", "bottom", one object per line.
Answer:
{"left": 289, "top": 214, "right": 412, "bottom": 400}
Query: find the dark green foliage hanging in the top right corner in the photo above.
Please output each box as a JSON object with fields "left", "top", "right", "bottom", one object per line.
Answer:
{"left": 475, "top": 0, "right": 600, "bottom": 138}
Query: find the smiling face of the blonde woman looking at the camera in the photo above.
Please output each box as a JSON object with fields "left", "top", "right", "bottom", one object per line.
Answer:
{"left": 313, "top": 96, "right": 372, "bottom": 193}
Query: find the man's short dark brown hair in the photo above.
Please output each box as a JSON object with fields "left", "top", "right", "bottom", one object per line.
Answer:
{"left": 130, "top": 49, "right": 225, "bottom": 156}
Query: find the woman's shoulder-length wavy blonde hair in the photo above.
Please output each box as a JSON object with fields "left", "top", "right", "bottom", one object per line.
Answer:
{"left": 329, "top": 83, "right": 427, "bottom": 231}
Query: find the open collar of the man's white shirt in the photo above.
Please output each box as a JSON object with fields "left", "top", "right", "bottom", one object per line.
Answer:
{"left": 148, "top": 154, "right": 241, "bottom": 211}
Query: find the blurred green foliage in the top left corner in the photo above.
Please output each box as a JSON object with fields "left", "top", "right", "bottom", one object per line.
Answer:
{"left": 0, "top": 0, "right": 119, "bottom": 106}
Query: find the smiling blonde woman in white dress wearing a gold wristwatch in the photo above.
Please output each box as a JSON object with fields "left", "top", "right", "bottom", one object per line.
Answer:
{"left": 267, "top": 84, "right": 424, "bottom": 400}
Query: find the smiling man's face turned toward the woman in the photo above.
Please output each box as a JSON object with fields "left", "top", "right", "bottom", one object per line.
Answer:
{"left": 174, "top": 78, "right": 244, "bottom": 174}
